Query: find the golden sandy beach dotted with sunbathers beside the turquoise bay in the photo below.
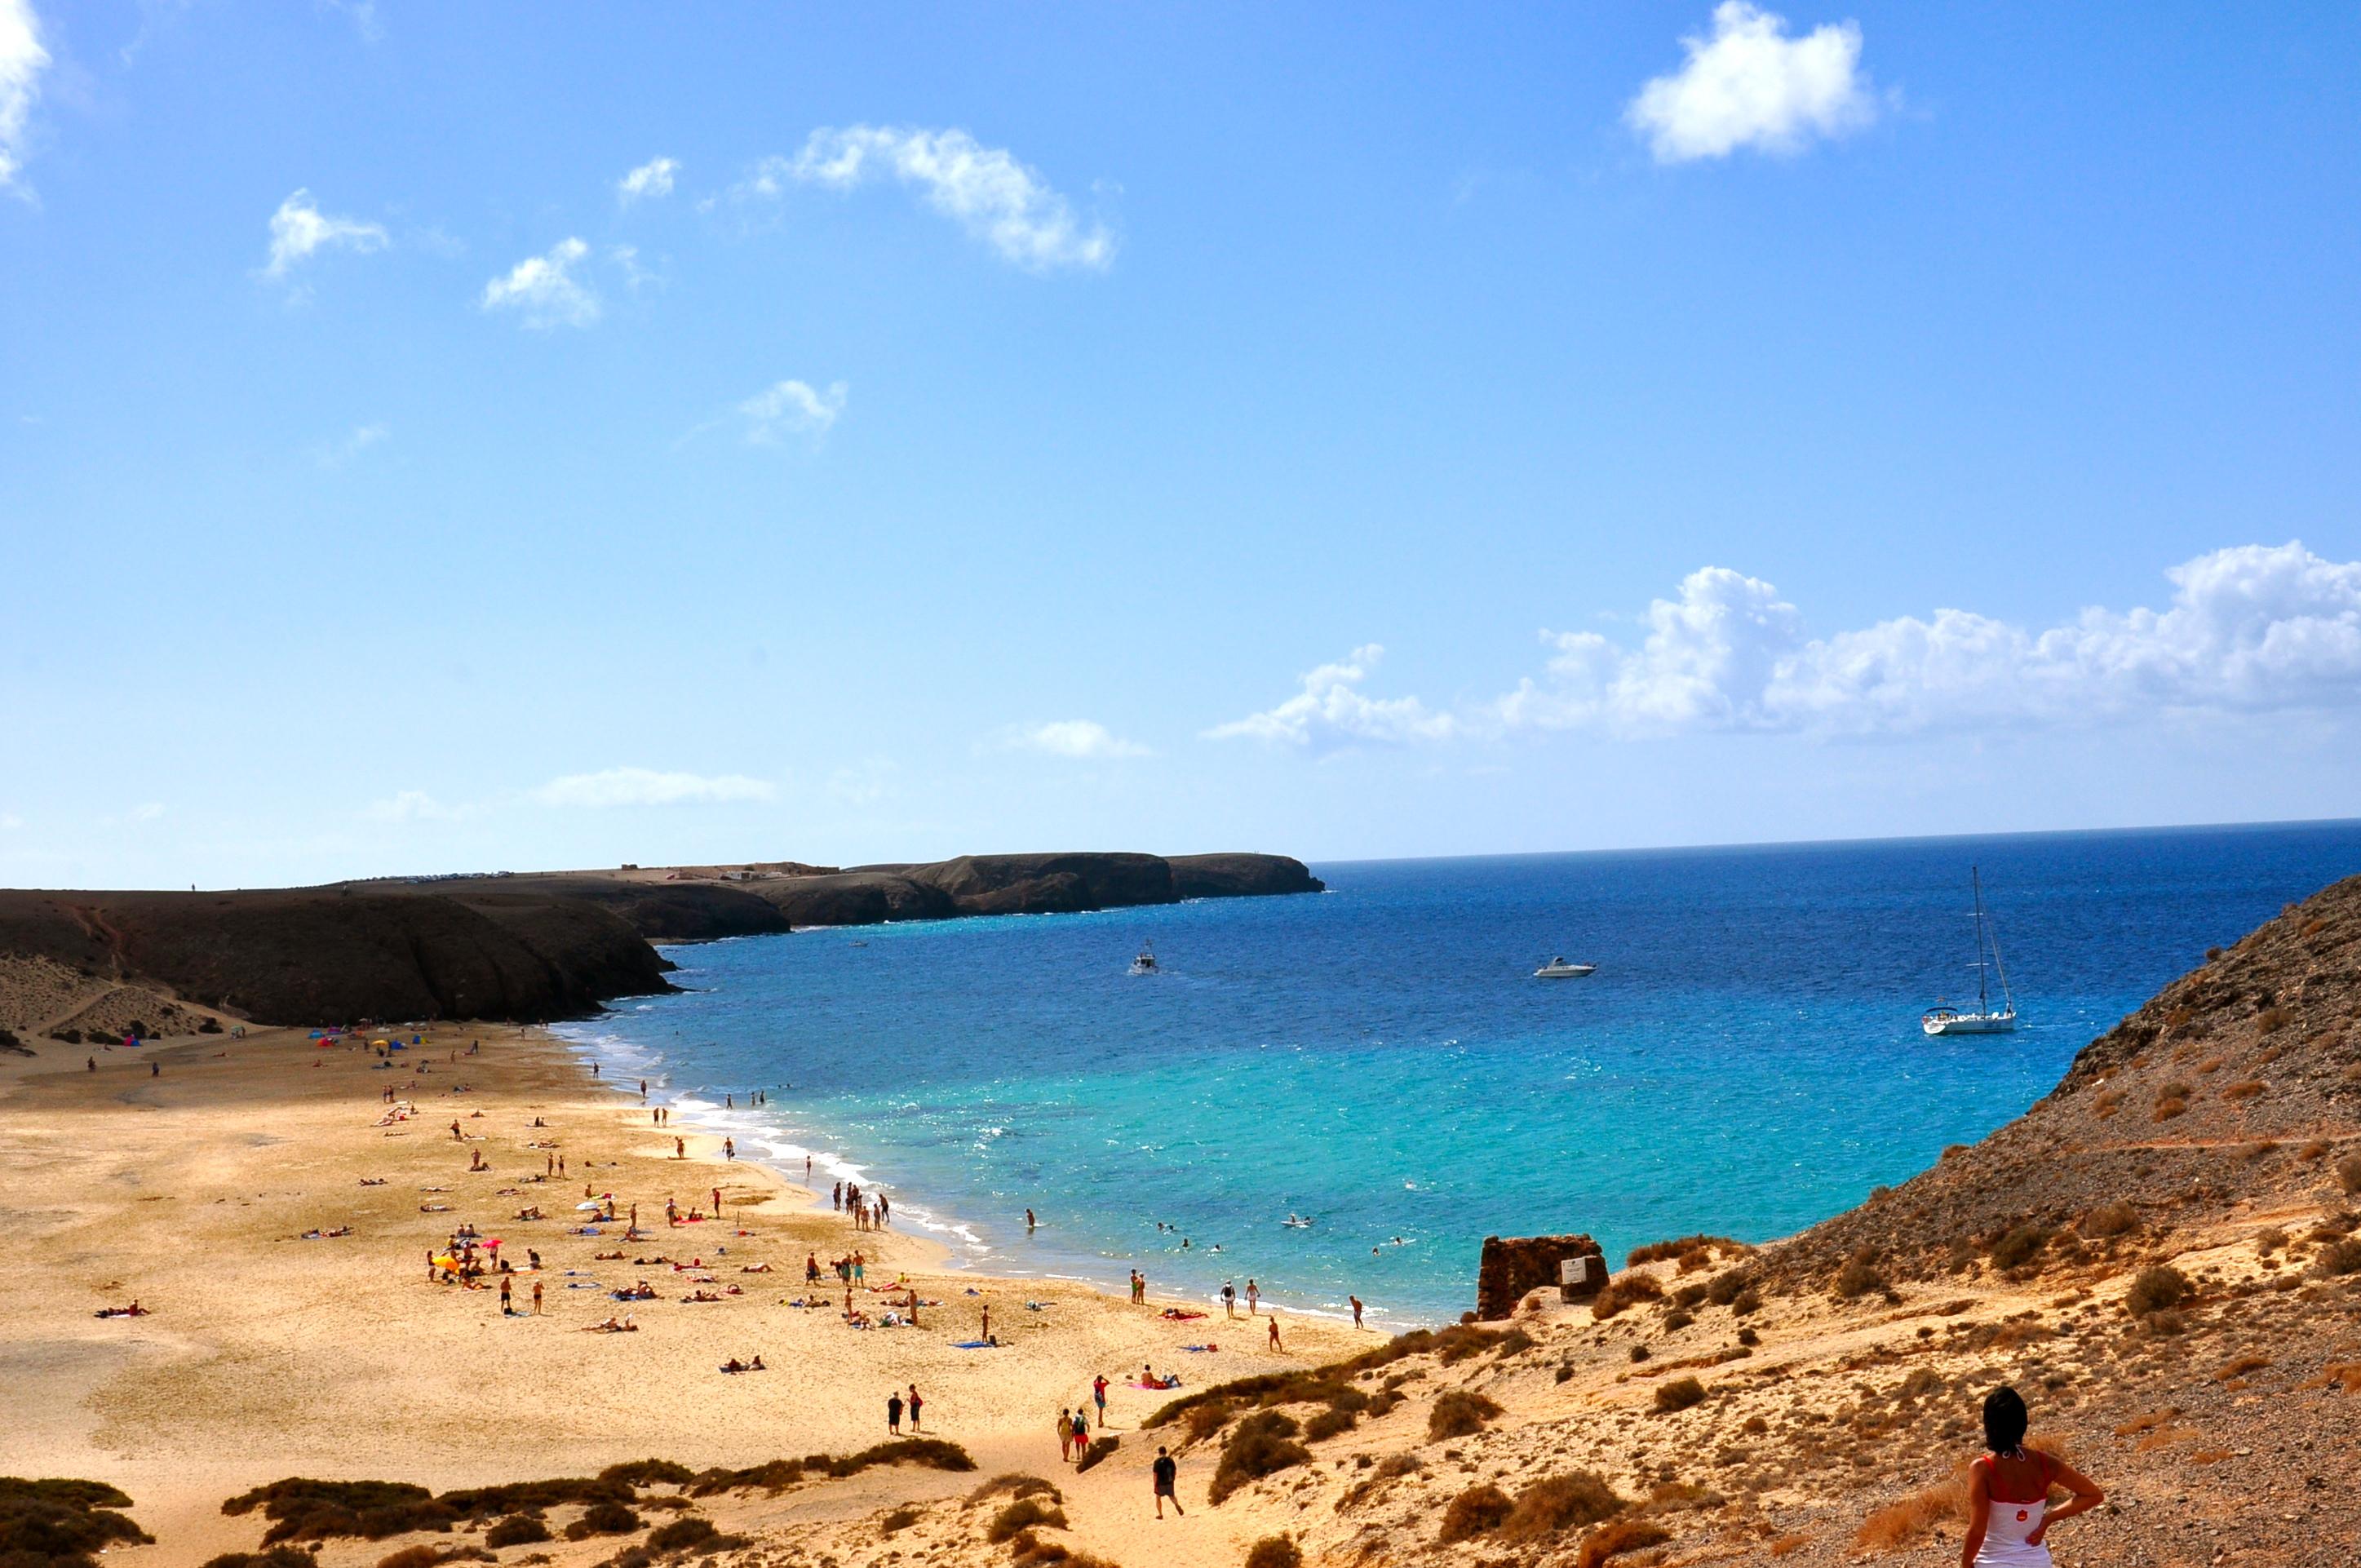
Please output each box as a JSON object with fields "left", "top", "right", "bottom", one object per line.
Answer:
{"left": 0, "top": 1025, "right": 1381, "bottom": 1568}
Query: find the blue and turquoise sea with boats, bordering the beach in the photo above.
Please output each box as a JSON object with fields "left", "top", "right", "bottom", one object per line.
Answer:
{"left": 567, "top": 822, "right": 2361, "bottom": 1325}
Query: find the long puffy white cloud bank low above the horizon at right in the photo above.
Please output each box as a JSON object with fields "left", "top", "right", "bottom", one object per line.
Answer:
{"left": 1492, "top": 543, "right": 2361, "bottom": 734}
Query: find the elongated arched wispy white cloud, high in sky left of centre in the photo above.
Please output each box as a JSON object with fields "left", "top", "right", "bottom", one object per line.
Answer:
{"left": 764, "top": 125, "right": 1114, "bottom": 272}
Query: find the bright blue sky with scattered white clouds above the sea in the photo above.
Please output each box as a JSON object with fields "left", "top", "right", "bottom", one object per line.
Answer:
{"left": 0, "top": 0, "right": 2361, "bottom": 885}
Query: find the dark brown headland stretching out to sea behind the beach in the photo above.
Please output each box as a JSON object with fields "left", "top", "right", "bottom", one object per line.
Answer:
{"left": 0, "top": 853, "right": 1322, "bottom": 1039}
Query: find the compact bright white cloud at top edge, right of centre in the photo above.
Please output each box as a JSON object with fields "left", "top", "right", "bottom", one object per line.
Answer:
{"left": 1624, "top": 0, "right": 1877, "bottom": 163}
